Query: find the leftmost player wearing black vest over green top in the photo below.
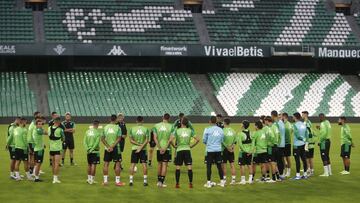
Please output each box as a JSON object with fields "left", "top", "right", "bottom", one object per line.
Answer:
{"left": 48, "top": 117, "right": 65, "bottom": 184}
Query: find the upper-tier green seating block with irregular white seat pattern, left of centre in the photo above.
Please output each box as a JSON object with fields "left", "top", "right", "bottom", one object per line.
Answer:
{"left": 45, "top": 0, "right": 199, "bottom": 44}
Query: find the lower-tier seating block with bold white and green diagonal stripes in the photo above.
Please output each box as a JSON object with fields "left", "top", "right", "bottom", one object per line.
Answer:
{"left": 209, "top": 73, "right": 360, "bottom": 116}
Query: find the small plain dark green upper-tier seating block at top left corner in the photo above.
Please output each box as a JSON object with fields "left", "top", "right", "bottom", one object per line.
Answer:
{"left": 0, "top": 0, "right": 34, "bottom": 43}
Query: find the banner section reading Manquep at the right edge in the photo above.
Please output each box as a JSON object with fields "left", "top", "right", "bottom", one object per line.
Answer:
{"left": 315, "top": 47, "right": 360, "bottom": 59}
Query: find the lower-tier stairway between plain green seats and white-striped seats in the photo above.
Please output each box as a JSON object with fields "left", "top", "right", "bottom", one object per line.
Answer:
{"left": 189, "top": 74, "right": 227, "bottom": 116}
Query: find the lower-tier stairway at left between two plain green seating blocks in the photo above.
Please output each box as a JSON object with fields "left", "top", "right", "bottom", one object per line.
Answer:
{"left": 27, "top": 73, "right": 50, "bottom": 116}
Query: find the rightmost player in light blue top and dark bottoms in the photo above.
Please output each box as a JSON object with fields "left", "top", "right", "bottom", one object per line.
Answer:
{"left": 293, "top": 112, "right": 308, "bottom": 180}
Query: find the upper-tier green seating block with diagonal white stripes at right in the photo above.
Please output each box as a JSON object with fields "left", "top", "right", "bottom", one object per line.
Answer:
{"left": 203, "top": 0, "right": 358, "bottom": 46}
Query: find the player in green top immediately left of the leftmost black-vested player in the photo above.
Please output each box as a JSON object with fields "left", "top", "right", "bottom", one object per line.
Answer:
{"left": 32, "top": 117, "right": 46, "bottom": 182}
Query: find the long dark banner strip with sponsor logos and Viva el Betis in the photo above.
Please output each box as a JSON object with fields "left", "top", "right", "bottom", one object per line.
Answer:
{"left": 0, "top": 43, "right": 271, "bottom": 57}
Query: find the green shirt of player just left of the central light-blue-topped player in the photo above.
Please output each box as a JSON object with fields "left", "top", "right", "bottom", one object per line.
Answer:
{"left": 174, "top": 128, "right": 195, "bottom": 152}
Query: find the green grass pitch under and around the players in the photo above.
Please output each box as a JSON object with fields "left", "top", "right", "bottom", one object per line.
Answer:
{"left": 0, "top": 124, "right": 360, "bottom": 203}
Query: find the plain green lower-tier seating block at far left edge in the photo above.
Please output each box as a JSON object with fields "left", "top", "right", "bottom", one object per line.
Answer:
{"left": 0, "top": 72, "right": 36, "bottom": 117}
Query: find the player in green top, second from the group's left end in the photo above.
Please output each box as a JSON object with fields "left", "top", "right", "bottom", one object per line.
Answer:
{"left": 12, "top": 118, "right": 32, "bottom": 181}
